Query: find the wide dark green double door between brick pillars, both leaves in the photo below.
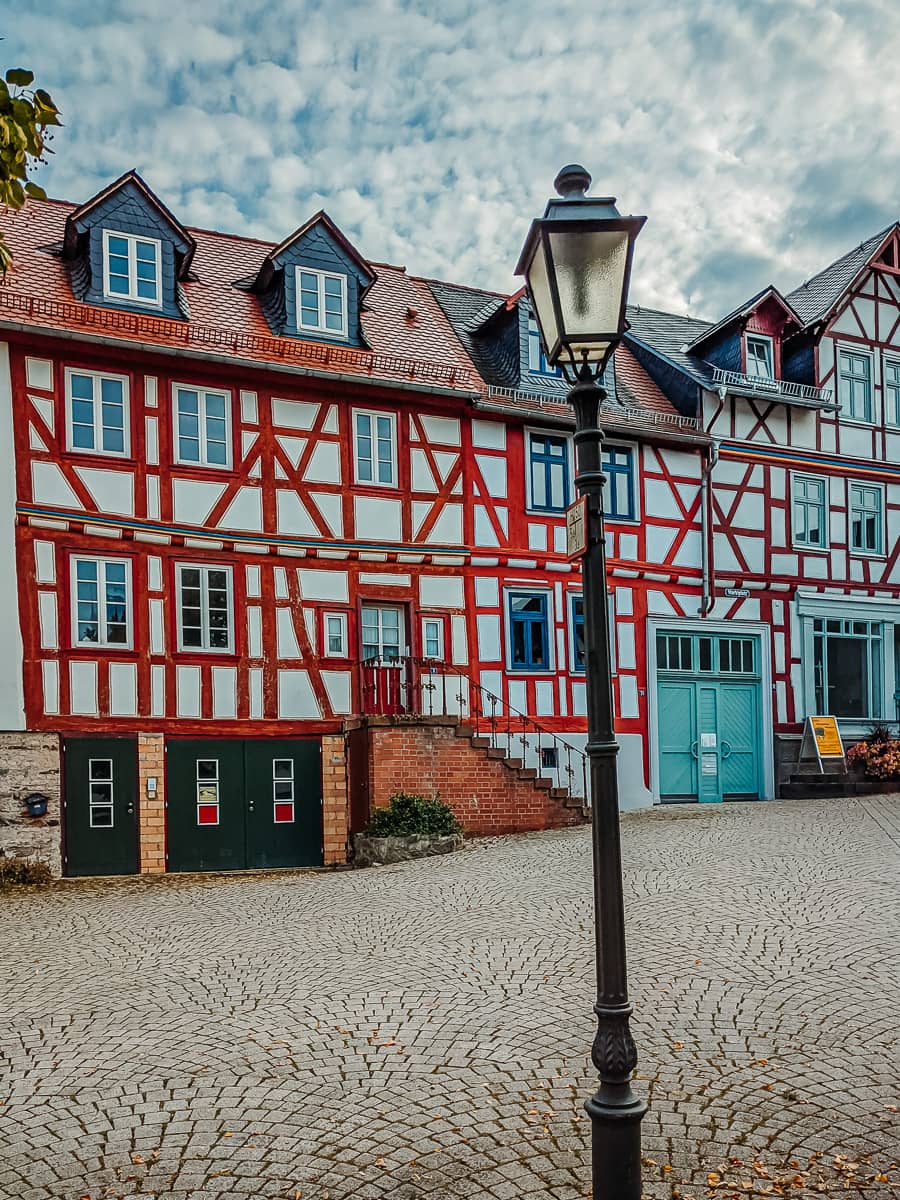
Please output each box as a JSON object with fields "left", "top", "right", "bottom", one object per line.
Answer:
{"left": 167, "top": 738, "right": 322, "bottom": 871}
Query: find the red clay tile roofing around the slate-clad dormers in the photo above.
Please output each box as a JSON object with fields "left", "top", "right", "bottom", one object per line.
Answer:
{"left": 0, "top": 200, "right": 677, "bottom": 436}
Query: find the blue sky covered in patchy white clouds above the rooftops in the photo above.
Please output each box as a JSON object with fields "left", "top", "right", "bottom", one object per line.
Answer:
{"left": 7, "top": 0, "right": 900, "bottom": 318}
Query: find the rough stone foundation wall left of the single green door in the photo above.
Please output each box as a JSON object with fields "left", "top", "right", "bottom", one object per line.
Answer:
{"left": 0, "top": 733, "right": 62, "bottom": 876}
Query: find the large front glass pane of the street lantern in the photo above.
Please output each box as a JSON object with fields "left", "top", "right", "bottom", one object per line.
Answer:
{"left": 547, "top": 229, "right": 629, "bottom": 356}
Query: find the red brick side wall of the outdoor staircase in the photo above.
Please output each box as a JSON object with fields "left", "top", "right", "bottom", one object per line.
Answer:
{"left": 368, "top": 722, "right": 580, "bottom": 834}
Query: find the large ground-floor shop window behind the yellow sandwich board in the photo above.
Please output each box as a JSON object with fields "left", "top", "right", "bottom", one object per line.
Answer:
{"left": 812, "top": 617, "right": 883, "bottom": 720}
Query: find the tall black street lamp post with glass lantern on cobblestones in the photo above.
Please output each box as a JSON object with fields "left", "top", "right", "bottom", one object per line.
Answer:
{"left": 516, "top": 166, "right": 647, "bottom": 1200}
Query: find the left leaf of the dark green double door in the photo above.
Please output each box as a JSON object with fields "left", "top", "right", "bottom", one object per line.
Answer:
{"left": 166, "top": 738, "right": 247, "bottom": 871}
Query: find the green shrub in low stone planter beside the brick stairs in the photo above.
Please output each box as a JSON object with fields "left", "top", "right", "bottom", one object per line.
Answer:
{"left": 353, "top": 792, "right": 462, "bottom": 866}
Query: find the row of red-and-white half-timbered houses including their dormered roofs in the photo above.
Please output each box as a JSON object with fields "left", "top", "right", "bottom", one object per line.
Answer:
{"left": 0, "top": 174, "right": 900, "bottom": 874}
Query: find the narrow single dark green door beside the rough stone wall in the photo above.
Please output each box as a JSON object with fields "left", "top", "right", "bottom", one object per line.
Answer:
{"left": 64, "top": 738, "right": 138, "bottom": 875}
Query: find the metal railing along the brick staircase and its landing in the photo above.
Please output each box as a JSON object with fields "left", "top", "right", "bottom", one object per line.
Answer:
{"left": 359, "top": 654, "right": 590, "bottom": 804}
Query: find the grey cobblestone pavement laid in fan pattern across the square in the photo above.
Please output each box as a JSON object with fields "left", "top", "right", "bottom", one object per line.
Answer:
{"left": 0, "top": 797, "right": 900, "bottom": 1200}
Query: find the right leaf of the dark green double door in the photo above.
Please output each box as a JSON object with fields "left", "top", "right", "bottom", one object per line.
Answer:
{"left": 244, "top": 738, "right": 322, "bottom": 866}
